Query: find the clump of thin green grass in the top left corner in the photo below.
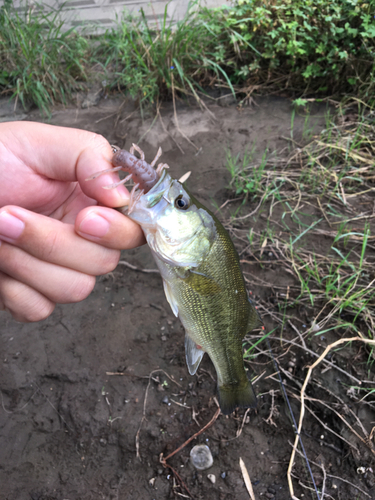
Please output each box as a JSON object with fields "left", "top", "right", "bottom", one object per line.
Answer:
{"left": 0, "top": 2, "right": 88, "bottom": 114}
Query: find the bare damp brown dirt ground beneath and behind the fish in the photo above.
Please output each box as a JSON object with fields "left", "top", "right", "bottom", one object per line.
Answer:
{"left": 0, "top": 97, "right": 375, "bottom": 500}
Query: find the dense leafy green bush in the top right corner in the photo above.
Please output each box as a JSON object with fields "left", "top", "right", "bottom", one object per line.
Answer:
{"left": 208, "top": 0, "right": 375, "bottom": 99}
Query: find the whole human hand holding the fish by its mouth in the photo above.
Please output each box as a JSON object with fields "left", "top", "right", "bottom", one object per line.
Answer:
{"left": 0, "top": 122, "right": 144, "bottom": 321}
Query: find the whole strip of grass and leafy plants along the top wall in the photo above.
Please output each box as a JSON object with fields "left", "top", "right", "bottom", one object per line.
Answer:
{"left": 0, "top": 0, "right": 375, "bottom": 114}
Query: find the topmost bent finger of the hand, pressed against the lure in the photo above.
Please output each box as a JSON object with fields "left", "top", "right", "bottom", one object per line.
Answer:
{"left": 0, "top": 122, "right": 129, "bottom": 207}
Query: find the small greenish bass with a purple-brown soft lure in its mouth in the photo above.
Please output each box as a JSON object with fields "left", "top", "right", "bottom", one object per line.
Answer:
{"left": 89, "top": 144, "right": 262, "bottom": 415}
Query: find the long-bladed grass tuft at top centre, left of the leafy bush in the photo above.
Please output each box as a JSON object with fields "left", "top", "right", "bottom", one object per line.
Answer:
{"left": 91, "top": 1, "right": 234, "bottom": 111}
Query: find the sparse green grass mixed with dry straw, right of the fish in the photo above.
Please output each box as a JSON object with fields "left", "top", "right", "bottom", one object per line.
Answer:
{"left": 226, "top": 101, "right": 375, "bottom": 346}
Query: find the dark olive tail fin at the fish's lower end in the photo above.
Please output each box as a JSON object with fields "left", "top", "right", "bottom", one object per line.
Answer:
{"left": 218, "top": 378, "right": 257, "bottom": 415}
